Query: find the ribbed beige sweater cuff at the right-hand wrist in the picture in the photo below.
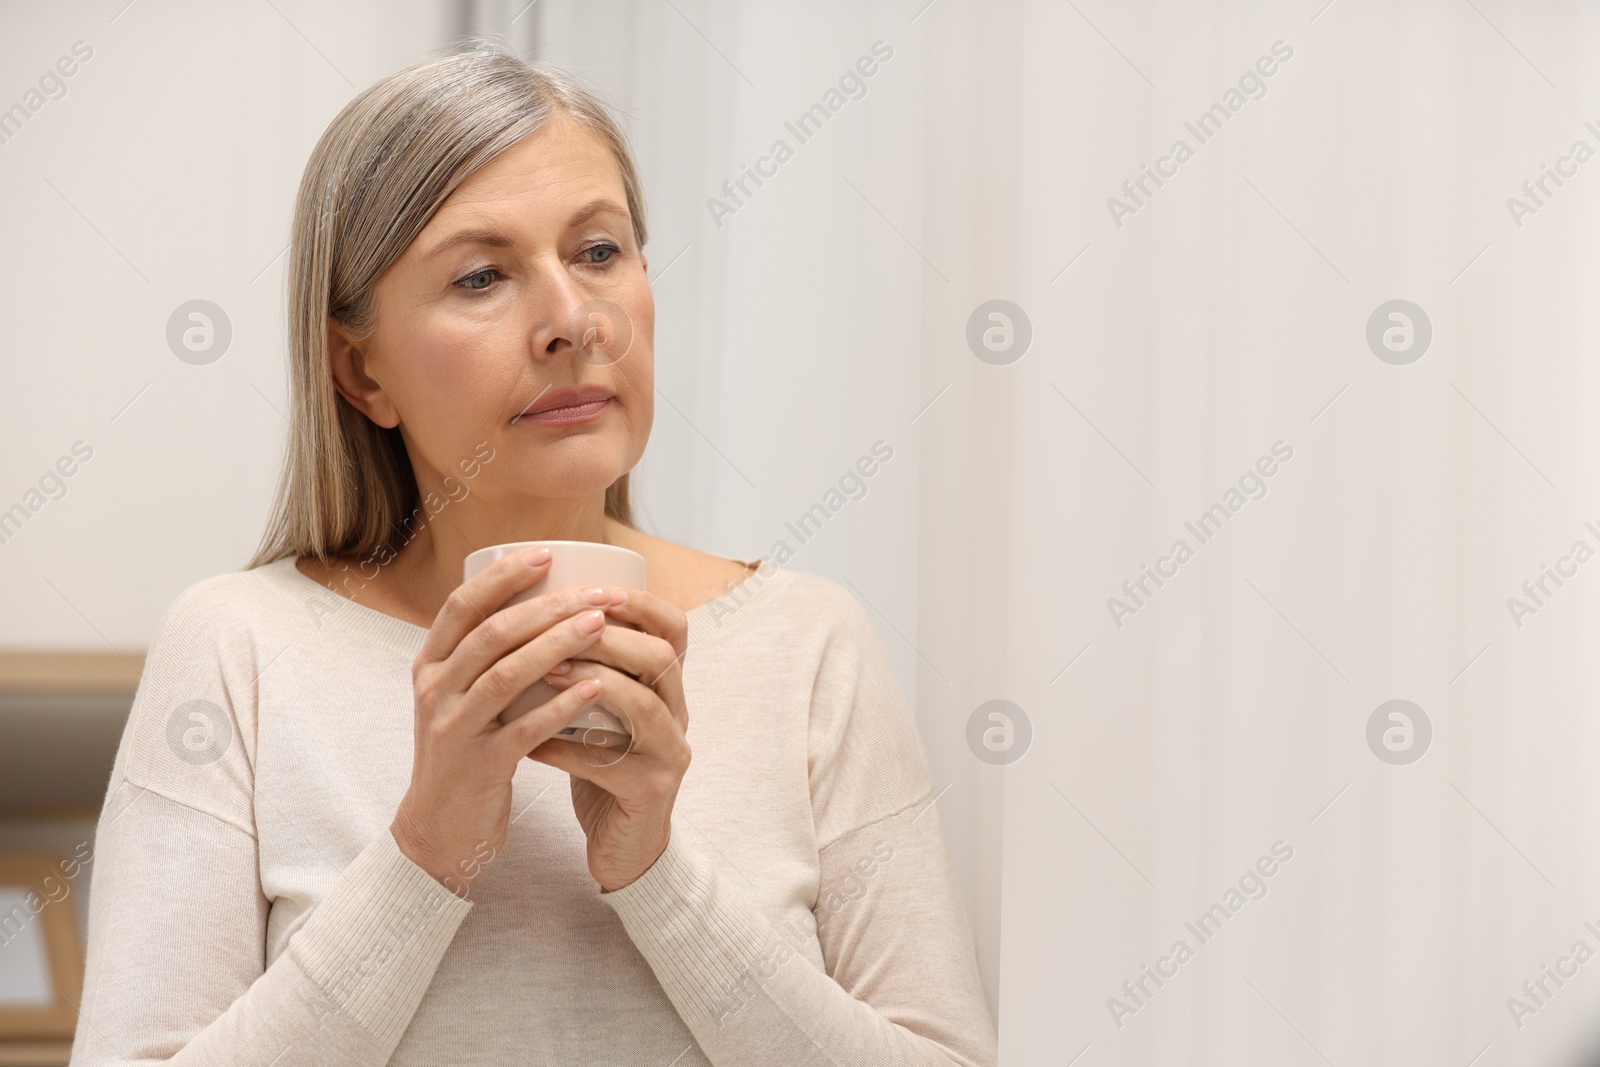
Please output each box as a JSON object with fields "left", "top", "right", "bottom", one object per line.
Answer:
{"left": 600, "top": 827, "right": 777, "bottom": 1025}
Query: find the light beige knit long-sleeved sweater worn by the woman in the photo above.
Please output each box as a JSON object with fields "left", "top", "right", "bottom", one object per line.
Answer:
{"left": 72, "top": 558, "right": 997, "bottom": 1067}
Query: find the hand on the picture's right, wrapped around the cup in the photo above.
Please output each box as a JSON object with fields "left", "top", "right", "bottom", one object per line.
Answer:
{"left": 528, "top": 585, "right": 690, "bottom": 893}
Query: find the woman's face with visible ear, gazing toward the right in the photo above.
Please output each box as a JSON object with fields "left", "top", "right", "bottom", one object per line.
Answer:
{"left": 330, "top": 112, "right": 656, "bottom": 506}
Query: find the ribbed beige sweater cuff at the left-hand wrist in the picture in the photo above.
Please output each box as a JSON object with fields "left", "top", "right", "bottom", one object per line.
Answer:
{"left": 290, "top": 827, "right": 472, "bottom": 1048}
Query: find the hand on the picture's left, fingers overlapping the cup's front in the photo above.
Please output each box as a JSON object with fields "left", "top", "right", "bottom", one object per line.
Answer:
{"left": 389, "top": 550, "right": 611, "bottom": 897}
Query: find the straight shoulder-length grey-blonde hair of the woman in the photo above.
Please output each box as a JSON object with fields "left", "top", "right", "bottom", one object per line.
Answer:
{"left": 245, "top": 45, "right": 646, "bottom": 569}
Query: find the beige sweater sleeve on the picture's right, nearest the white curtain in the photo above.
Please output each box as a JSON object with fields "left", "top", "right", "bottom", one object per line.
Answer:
{"left": 600, "top": 587, "right": 998, "bottom": 1067}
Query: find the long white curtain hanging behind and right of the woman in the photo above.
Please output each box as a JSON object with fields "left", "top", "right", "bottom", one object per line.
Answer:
{"left": 534, "top": 0, "right": 1600, "bottom": 1067}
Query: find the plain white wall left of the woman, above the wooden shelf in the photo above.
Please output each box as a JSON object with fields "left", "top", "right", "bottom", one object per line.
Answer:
{"left": 0, "top": 0, "right": 453, "bottom": 649}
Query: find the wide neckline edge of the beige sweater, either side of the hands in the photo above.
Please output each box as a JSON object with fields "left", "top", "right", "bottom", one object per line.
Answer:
{"left": 256, "top": 555, "right": 794, "bottom": 659}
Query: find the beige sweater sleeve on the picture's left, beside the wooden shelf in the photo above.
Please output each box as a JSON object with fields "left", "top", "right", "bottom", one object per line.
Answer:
{"left": 70, "top": 579, "right": 472, "bottom": 1067}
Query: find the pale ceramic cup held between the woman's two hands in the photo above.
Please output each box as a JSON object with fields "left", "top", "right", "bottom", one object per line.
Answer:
{"left": 461, "top": 541, "right": 645, "bottom": 749}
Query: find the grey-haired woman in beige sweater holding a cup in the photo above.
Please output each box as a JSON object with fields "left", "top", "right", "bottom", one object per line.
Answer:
{"left": 72, "top": 51, "right": 997, "bottom": 1067}
